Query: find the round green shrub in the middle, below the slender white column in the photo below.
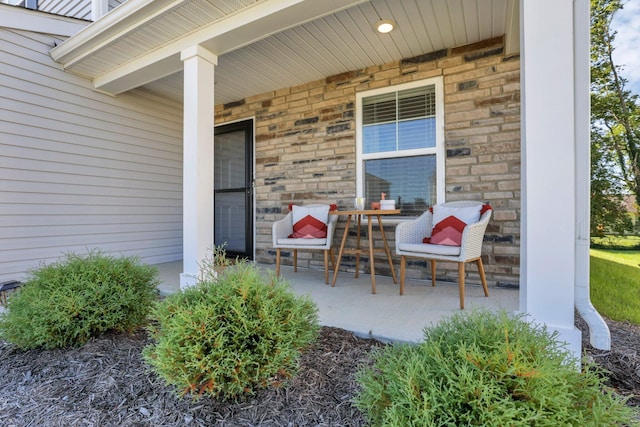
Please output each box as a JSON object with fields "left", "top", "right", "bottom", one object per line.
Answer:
{"left": 143, "top": 261, "right": 319, "bottom": 398}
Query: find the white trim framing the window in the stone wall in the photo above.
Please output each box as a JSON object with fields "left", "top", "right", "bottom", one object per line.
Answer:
{"left": 356, "top": 77, "right": 445, "bottom": 204}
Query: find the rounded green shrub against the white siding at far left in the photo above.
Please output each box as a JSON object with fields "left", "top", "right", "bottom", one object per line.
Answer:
{"left": 0, "top": 251, "right": 158, "bottom": 349}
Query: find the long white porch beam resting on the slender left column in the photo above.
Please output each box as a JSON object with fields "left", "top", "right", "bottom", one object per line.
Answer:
{"left": 93, "top": 0, "right": 368, "bottom": 95}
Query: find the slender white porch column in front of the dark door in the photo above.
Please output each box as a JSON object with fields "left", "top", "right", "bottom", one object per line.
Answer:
{"left": 180, "top": 46, "right": 218, "bottom": 289}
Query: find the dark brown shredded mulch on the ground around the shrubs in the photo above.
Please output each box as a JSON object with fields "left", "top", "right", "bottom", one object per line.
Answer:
{"left": 0, "top": 320, "right": 640, "bottom": 426}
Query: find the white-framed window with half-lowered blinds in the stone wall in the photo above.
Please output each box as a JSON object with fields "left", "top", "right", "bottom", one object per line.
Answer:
{"left": 358, "top": 79, "right": 443, "bottom": 215}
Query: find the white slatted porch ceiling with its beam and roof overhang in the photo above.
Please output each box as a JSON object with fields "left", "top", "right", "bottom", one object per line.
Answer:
{"left": 51, "top": 0, "right": 519, "bottom": 103}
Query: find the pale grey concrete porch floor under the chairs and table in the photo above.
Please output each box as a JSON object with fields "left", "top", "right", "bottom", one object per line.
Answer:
{"left": 156, "top": 261, "right": 519, "bottom": 342}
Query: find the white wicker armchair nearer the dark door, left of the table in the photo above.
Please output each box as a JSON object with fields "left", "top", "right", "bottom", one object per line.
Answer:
{"left": 272, "top": 205, "right": 338, "bottom": 284}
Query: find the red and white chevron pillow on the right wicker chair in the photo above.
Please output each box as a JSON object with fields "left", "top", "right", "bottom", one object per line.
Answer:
{"left": 429, "top": 205, "right": 482, "bottom": 246}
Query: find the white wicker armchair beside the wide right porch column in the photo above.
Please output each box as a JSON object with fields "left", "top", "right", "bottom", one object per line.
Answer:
{"left": 396, "top": 201, "right": 491, "bottom": 309}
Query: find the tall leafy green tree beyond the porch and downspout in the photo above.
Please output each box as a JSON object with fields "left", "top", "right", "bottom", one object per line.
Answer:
{"left": 591, "top": 0, "right": 640, "bottom": 236}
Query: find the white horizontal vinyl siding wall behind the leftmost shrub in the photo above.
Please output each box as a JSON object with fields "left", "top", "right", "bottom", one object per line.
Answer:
{"left": 0, "top": 28, "right": 182, "bottom": 282}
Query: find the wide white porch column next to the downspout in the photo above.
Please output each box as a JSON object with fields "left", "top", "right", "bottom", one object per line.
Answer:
{"left": 520, "top": 0, "right": 588, "bottom": 357}
